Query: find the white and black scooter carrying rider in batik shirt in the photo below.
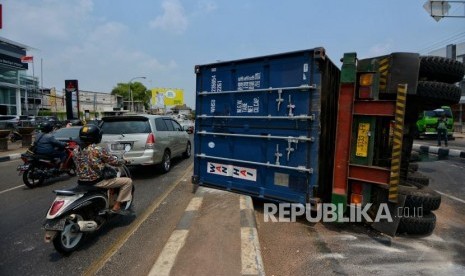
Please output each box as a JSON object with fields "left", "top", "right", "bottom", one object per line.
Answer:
{"left": 43, "top": 165, "right": 134, "bottom": 256}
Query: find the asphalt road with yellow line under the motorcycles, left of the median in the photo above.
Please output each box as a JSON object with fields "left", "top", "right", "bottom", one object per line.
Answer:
{"left": 0, "top": 154, "right": 193, "bottom": 275}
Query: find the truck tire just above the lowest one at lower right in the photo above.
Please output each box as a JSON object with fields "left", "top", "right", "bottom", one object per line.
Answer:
{"left": 399, "top": 183, "right": 441, "bottom": 214}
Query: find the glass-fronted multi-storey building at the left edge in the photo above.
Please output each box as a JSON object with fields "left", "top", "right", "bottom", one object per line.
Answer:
{"left": 0, "top": 37, "right": 43, "bottom": 115}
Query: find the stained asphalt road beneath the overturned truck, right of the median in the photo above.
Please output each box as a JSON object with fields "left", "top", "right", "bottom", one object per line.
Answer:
{"left": 255, "top": 156, "right": 465, "bottom": 275}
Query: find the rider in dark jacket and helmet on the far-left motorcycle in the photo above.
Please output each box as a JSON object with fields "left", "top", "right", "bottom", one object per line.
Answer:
{"left": 34, "top": 122, "right": 66, "bottom": 170}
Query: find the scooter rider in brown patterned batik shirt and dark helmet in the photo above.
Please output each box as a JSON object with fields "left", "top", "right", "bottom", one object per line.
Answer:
{"left": 74, "top": 125, "right": 132, "bottom": 215}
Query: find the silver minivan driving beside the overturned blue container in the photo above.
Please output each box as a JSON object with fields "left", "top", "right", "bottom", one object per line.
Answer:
{"left": 101, "top": 115, "right": 191, "bottom": 172}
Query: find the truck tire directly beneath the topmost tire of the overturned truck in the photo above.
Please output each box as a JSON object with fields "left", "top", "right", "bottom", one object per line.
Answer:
{"left": 409, "top": 81, "right": 462, "bottom": 109}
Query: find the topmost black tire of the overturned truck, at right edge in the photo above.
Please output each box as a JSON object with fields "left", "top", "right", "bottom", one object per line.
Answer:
{"left": 419, "top": 56, "right": 465, "bottom": 83}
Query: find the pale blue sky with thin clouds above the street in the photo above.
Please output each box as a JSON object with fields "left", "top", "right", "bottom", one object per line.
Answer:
{"left": 0, "top": 0, "right": 465, "bottom": 108}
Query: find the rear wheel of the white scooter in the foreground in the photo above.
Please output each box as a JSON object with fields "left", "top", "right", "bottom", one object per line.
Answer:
{"left": 53, "top": 214, "right": 84, "bottom": 256}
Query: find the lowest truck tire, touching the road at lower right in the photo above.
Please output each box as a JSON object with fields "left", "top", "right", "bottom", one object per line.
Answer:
{"left": 397, "top": 213, "right": 436, "bottom": 235}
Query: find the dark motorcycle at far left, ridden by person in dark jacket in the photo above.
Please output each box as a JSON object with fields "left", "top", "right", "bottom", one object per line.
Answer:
{"left": 16, "top": 140, "right": 79, "bottom": 189}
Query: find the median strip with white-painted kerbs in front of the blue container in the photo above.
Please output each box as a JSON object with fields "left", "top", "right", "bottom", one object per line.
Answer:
{"left": 149, "top": 187, "right": 265, "bottom": 276}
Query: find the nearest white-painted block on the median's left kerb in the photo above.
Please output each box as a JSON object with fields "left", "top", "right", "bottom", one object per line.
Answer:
{"left": 149, "top": 230, "right": 189, "bottom": 276}
